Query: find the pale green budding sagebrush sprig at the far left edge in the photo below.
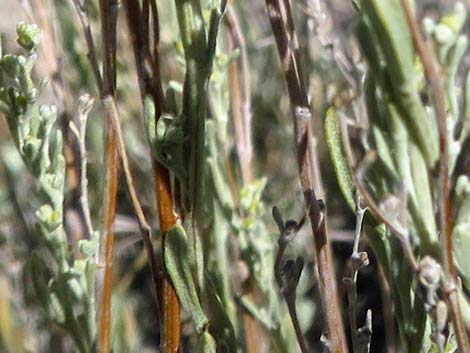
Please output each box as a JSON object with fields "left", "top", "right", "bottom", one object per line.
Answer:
{"left": 0, "top": 23, "right": 97, "bottom": 352}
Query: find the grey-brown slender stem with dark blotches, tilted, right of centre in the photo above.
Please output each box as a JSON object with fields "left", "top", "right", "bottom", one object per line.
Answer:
{"left": 266, "top": 0, "right": 348, "bottom": 353}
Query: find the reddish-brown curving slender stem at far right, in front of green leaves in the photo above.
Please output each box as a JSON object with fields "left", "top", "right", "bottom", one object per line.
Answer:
{"left": 401, "top": 0, "right": 470, "bottom": 353}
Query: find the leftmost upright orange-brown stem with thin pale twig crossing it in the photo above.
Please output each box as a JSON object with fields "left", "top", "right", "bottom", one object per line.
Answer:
{"left": 74, "top": 0, "right": 140, "bottom": 353}
